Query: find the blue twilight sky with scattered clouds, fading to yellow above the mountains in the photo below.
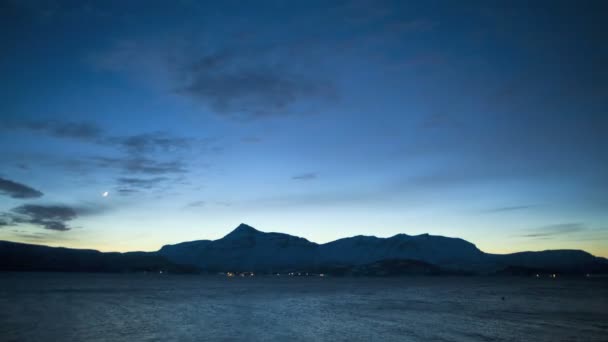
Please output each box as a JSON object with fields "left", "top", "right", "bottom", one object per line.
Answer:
{"left": 0, "top": 0, "right": 608, "bottom": 257}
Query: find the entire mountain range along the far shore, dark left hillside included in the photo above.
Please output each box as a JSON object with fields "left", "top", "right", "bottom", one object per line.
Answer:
{"left": 0, "top": 224, "right": 608, "bottom": 275}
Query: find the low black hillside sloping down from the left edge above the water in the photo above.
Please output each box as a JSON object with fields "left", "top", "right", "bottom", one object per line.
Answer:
{"left": 0, "top": 241, "right": 197, "bottom": 273}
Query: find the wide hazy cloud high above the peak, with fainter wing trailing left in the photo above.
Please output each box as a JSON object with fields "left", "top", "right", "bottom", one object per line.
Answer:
{"left": 92, "top": 32, "right": 336, "bottom": 119}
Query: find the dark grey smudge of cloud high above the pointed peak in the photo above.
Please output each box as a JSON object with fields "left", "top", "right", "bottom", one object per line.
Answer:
{"left": 178, "top": 52, "right": 335, "bottom": 118}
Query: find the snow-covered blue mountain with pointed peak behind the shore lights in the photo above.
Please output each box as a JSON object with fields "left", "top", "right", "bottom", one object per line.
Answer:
{"left": 158, "top": 224, "right": 608, "bottom": 274}
